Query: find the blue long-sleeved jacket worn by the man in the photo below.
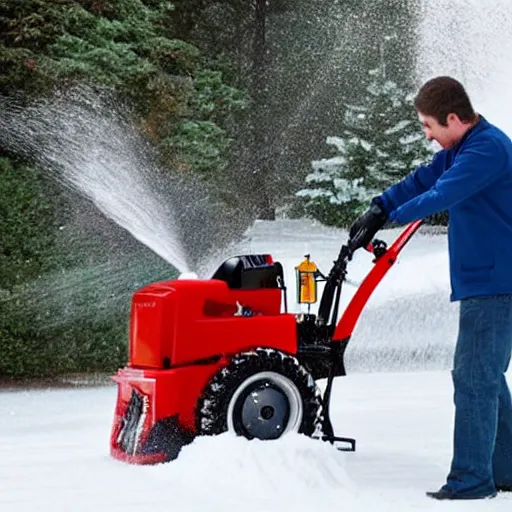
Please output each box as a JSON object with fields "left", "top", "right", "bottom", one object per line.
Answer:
{"left": 377, "top": 117, "right": 512, "bottom": 301}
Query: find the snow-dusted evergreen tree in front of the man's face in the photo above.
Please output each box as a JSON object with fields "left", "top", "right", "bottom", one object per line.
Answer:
{"left": 297, "top": 64, "right": 431, "bottom": 226}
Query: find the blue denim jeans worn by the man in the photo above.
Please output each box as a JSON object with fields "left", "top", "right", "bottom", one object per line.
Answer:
{"left": 445, "top": 295, "right": 512, "bottom": 496}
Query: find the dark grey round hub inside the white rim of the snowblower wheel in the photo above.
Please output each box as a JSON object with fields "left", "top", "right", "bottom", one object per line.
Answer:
{"left": 233, "top": 380, "right": 290, "bottom": 439}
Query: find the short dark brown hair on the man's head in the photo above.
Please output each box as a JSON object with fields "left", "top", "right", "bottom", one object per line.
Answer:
{"left": 414, "top": 76, "right": 475, "bottom": 126}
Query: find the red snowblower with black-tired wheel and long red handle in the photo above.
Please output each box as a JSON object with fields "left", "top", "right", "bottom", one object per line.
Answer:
{"left": 110, "top": 221, "right": 421, "bottom": 464}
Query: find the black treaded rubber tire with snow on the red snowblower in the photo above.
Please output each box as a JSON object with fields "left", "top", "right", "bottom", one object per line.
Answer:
{"left": 196, "top": 348, "right": 322, "bottom": 436}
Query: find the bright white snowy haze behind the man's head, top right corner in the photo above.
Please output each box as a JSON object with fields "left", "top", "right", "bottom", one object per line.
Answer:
{"left": 417, "top": 0, "right": 512, "bottom": 136}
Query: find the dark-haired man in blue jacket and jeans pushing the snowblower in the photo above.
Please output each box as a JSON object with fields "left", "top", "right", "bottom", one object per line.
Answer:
{"left": 350, "top": 77, "right": 512, "bottom": 499}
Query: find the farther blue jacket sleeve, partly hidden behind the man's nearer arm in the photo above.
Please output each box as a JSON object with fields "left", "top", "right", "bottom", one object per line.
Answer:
{"left": 378, "top": 150, "right": 447, "bottom": 214}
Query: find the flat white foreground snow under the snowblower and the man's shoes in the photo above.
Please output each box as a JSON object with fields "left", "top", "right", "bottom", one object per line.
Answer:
{"left": 0, "top": 371, "right": 512, "bottom": 512}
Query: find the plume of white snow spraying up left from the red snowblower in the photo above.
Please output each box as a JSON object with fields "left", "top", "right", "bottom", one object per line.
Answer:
{"left": 0, "top": 87, "right": 190, "bottom": 272}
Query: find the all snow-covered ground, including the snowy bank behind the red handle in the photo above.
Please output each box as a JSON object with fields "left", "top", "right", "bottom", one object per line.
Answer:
{"left": 0, "top": 222, "right": 512, "bottom": 512}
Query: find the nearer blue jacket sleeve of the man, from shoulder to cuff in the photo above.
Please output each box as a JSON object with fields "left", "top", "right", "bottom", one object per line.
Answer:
{"left": 390, "top": 139, "right": 507, "bottom": 224}
